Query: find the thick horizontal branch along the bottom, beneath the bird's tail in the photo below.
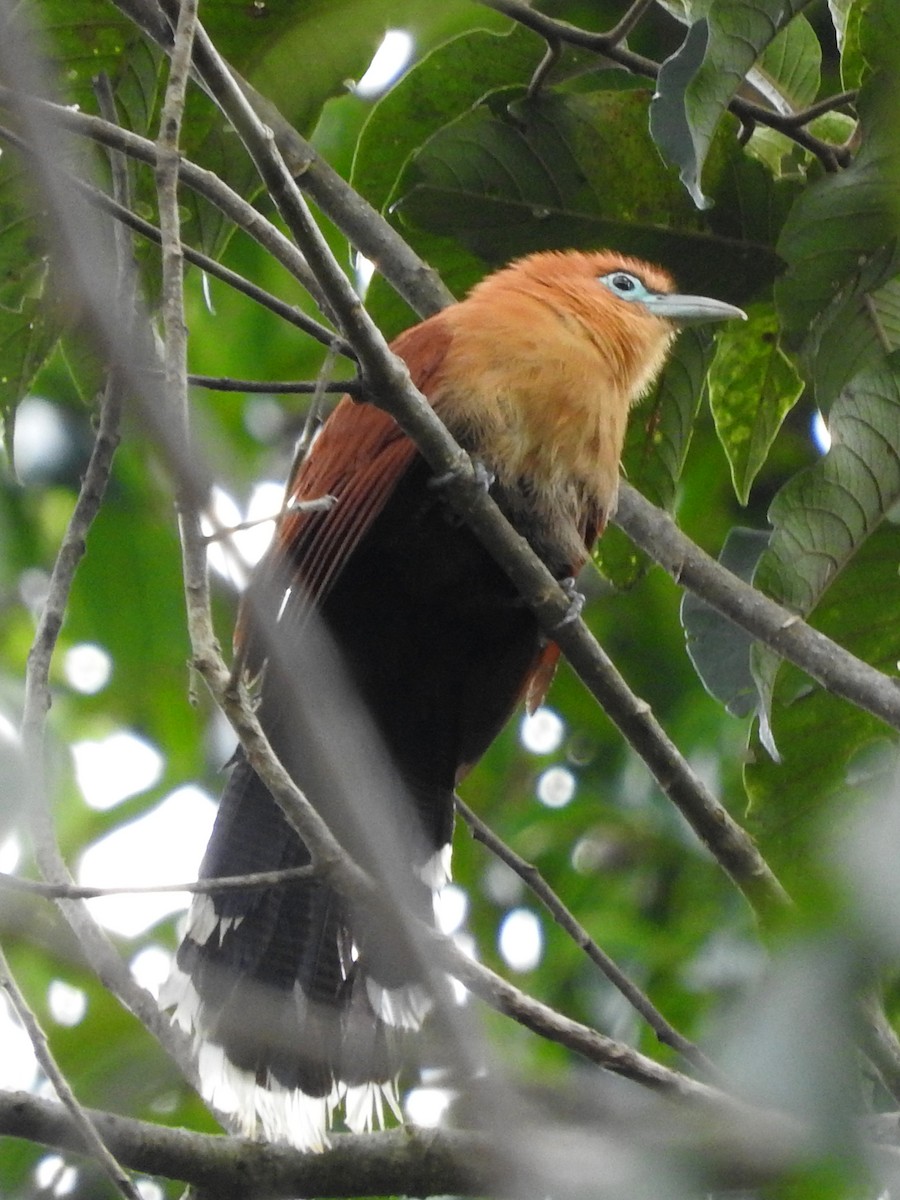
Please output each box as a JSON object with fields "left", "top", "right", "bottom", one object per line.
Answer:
{"left": 0, "top": 1091, "right": 900, "bottom": 1200}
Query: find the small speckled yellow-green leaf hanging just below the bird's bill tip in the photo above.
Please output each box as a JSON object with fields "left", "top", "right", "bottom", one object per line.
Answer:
{"left": 709, "top": 306, "right": 803, "bottom": 504}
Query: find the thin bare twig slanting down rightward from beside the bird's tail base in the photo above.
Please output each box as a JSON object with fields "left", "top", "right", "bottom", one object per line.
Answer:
{"left": 456, "top": 796, "right": 718, "bottom": 1079}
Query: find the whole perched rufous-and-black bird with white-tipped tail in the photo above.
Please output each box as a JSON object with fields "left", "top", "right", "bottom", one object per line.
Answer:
{"left": 166, "top": 251, "right": 744, "bottom": 1148}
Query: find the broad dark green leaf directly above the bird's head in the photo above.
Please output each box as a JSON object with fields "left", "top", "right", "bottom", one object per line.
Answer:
{"left": 395, "top": 90, "right": 780, "bottom": 300}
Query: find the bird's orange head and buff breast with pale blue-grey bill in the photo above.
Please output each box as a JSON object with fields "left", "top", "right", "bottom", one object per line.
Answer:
{"left": 422, "top": 251, "right": 744, "bottom": 525}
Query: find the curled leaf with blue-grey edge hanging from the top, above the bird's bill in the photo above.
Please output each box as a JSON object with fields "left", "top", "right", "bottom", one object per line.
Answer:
{"left": 650, "top": 0, "right": 809, "bottom": 208}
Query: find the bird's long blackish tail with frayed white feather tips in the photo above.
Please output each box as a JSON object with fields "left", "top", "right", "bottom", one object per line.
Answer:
{"left": 162, "top": 752, "right": 442, "bottom": 1150}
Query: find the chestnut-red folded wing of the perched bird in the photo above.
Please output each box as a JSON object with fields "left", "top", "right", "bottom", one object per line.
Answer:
{"left": 238, "top": 314, "right": 451, "bottom": 666}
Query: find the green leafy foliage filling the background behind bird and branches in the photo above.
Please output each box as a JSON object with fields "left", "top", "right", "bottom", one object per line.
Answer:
{"left": 0, "top": 0, "right": 900, "bottom": 1195}
